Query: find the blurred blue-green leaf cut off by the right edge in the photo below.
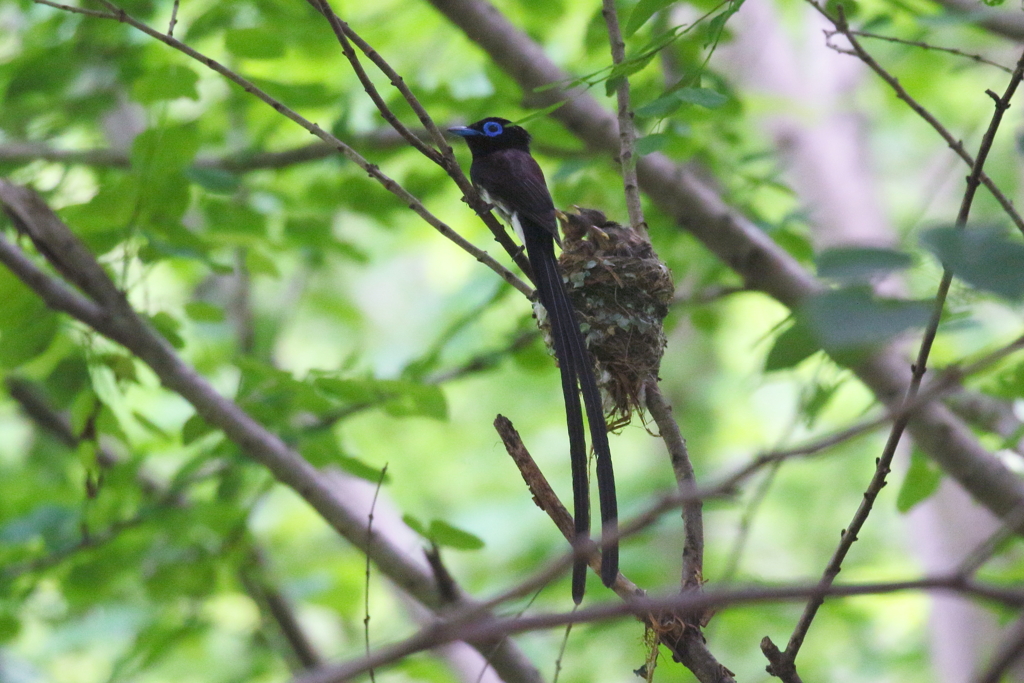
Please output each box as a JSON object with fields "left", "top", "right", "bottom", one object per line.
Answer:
{"left": 921, "top": 225, "right": 1024, "bottom": 300}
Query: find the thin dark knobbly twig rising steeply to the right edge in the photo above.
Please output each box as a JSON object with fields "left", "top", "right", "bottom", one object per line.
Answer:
{"left": 770, "top": 31, "right": 1024, "bottom": 664}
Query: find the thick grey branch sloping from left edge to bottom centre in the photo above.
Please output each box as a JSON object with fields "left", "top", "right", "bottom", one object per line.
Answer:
{"left": 0, "top": 180, "right": 541, "bottom": 682}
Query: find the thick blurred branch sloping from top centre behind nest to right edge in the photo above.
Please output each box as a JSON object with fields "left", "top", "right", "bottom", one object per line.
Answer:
{"left": 430, "top": 0, "right": 1024, "bottom": 548}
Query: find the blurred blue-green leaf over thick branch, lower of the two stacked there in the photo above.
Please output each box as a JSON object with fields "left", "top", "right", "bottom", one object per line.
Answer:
{"left": 800, "top": 287, "right": 932, "bottom": 350}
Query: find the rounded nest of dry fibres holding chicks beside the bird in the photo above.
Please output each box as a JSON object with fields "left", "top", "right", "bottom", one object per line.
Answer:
{"left": 536, "top": 207, "right": 675, "bottom": 429}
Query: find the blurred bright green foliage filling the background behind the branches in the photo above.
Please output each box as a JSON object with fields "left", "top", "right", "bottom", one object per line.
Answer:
{"left": 0, "top": 0, "right": 1024, "bottom": 683}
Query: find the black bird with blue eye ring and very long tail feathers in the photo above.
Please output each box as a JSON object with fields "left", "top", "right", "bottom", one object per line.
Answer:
{"left": 449, "top": 117, "right": 618, "bottom": 604}
